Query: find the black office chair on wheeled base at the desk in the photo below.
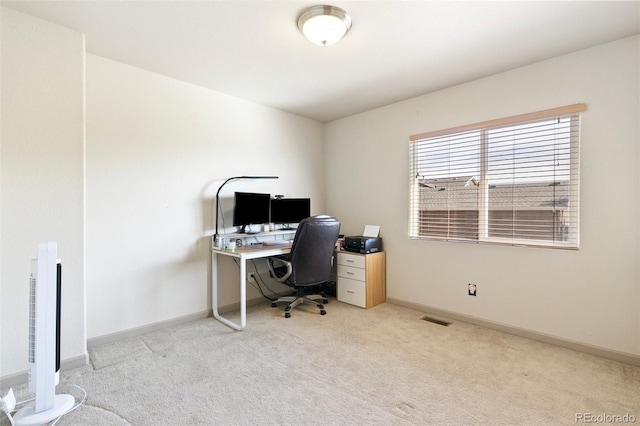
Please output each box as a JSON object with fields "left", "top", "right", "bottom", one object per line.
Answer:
{"left": 268, "top": 215, "right": 340, "bottom": 318}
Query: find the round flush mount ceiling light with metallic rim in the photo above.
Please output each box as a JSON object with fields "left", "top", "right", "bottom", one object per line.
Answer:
{"left": 298, "top": 6, "right": 351, "bottom": 46}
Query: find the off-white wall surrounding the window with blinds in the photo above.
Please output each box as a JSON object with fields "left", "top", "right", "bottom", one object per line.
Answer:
{"left": 325, "top": 37, "right": 640, "bottom": 355}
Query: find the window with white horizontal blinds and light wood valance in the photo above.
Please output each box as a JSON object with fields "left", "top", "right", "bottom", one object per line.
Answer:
{"left": 409, "top": 104, "right": 585, "bottom": 249}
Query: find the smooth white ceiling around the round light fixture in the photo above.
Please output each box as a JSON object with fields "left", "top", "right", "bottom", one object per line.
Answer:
{"left": 0, "top": 0, "right": 640, "bottom": 122}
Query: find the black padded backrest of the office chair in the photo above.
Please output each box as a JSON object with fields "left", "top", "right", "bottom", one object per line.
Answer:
{"left": 287, "top": 215, "right": 340, "bottom": 286}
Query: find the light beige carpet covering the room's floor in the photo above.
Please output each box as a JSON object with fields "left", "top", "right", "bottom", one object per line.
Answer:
{"left": 1, "top": 299, "right": 640, "bottom": 426}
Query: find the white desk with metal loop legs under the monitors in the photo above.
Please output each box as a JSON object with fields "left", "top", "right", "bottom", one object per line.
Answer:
{"left": 211, "top": 231, "right": 295, "bottom": 331}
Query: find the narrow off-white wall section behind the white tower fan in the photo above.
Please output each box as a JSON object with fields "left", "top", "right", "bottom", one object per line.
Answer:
{"left": 0, "top": 7, "right": 86, "bottom": 377}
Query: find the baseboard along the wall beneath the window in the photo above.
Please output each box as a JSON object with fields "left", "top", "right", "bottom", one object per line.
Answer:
{"left": 387, "top": 297, "right": 640, "bottom": 366}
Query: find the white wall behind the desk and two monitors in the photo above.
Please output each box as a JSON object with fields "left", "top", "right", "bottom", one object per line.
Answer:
{"left": 86, "top": 55, "right": 325, "bottom": 338}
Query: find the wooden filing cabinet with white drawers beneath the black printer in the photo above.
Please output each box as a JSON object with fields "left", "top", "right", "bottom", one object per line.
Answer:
{"left": 336, "top": 251, "right": 387, "bottom": 308}
